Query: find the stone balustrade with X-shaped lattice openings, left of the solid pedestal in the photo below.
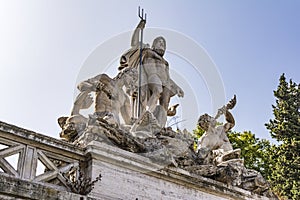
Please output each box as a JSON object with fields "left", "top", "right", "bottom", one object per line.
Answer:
{"left": 0, "top": 122, "right": 85, "bottom": 199}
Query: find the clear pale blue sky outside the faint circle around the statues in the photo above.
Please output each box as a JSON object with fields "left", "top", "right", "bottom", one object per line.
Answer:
{"left": 0, "top": 0, "right": 300, "bottom": 139}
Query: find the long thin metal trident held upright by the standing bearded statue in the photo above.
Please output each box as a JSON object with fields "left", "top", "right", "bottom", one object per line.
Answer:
{"left": 137, "top": 6, "right": 147, "bottom": 118}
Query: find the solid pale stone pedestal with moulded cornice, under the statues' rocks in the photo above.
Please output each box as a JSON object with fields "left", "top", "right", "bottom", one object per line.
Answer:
{"left": 86, "top": 141, "right": 267, "bottom": 200}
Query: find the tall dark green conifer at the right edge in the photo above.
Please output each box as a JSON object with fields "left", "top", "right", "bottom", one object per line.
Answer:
{"left": 266, "top": 74, "right": 300, "bottom": 199}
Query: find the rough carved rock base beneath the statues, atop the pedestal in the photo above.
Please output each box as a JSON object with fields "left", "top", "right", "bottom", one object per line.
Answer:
{"left": 75, "top": 116, "right": 273, "bottom": 197}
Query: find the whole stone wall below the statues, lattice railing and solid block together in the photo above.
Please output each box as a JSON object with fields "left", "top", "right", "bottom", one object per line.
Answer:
{"left": 0, "top": 122, "right": 267, "bottom": 200}
